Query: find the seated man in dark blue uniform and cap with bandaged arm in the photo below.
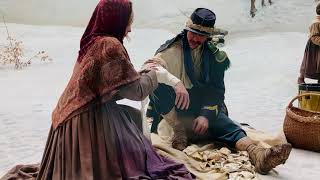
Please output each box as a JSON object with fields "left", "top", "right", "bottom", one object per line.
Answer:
{"left": 144, "top": 8, "right": 292, "bottom": 174}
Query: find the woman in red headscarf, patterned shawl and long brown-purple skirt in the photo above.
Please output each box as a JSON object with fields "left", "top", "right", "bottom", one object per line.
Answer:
{"left": 37, "top": 0, "right": 193, "bottom": 180}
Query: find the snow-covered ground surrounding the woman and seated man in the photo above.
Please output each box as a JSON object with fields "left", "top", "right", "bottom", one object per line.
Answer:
{"left": 0, "top": 0, "right": 320, "bottom": 180}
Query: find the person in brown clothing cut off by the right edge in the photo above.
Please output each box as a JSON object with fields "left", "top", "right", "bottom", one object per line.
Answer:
{"left": 298, "top": 3, "right": 320, "bottom": 84}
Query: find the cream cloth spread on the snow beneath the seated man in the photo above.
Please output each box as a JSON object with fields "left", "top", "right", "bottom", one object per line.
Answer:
{"left": 151, "top": 121, "right": 286, "bottom": 180}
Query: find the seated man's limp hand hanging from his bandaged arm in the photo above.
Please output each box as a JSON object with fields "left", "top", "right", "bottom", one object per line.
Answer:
{"left": 173, "top": 81, "right": 190, "bottom": 110}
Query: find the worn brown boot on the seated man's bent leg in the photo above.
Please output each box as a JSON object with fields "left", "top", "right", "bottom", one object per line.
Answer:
{"left": 163, "top": 108, "right": 188, "bottom": 151}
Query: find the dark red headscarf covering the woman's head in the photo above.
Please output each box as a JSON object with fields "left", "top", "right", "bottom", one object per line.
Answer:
{"left": 77, "top": 0, "right": 132, "bottom": 62}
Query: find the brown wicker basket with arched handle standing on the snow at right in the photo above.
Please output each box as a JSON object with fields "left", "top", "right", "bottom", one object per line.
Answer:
{"left": 283, "top": 93, "right": 320, "bottom": 152}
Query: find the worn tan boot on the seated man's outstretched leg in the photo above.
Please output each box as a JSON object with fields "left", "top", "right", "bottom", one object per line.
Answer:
{"left": 236, "top": 137, "right": 292, "bottom": 174}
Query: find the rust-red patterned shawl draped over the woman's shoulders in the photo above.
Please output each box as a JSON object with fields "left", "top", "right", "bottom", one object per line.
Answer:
{"left": 52, "top": 37, "right": 140, "bottom": 128}
